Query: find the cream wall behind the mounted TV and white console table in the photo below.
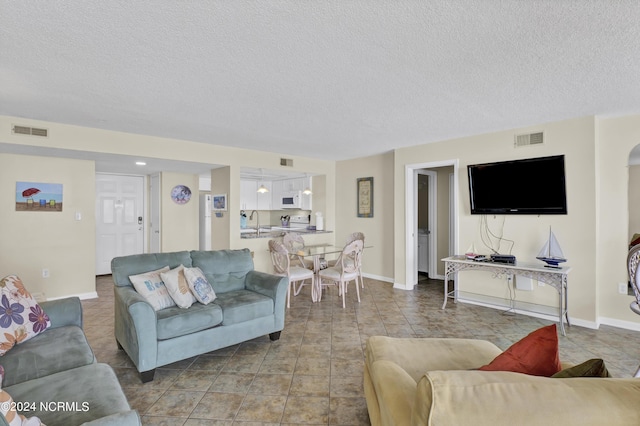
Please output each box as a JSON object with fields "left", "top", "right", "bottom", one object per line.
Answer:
{"left": 394, "top": 117, "right": 597, "bottom": 324}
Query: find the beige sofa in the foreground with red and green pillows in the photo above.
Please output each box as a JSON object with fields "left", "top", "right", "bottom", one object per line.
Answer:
{"left": 364, "top": 336, "right": 640, "bottom": 426}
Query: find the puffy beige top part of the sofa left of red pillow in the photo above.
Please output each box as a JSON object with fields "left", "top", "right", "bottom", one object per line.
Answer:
{"left": 365, "top": 336, "right": 502, "bottom": 382}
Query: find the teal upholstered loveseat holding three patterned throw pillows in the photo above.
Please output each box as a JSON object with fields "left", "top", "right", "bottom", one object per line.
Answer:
{"left": 111, "top": 249, "right": 288, "bottom": 382}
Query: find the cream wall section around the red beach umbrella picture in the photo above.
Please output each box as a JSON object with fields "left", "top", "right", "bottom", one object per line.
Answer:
{"left": 0, "top": 154, "right": 95, "bottom": 298}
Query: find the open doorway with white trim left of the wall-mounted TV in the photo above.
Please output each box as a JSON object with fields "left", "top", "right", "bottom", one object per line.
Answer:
{"left": 405, "top": 160, "right": 458, "bottom": 290}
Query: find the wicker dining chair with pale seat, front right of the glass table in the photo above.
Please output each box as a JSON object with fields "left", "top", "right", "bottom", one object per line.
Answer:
{"left": 317, "top": 240, "right": 364, "bottom": 309}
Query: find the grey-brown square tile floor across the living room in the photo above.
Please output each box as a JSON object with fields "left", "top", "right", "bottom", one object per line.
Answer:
{"left": 82, "top": 276, "right": 640, "bottom": 426}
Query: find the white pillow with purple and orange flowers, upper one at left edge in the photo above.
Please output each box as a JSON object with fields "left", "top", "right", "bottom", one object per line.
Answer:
{"left": 0, "top": 275, "right": 51, "bottom": 356}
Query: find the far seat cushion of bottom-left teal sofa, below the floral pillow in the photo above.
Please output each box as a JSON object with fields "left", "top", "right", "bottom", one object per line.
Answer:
{"left": 1, "top": 325, "right": 95, "bottom": 386}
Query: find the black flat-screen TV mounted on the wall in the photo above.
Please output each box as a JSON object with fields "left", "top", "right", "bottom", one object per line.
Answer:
{"left": 467, "top": 155, "right": 567, "bottom": 214}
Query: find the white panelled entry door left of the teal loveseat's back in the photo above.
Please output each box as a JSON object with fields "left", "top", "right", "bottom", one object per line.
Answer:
{"left": 96, "top": 173, "right": 144, "bottom": 275}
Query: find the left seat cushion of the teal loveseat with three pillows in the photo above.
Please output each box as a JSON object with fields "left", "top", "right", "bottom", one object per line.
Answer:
{"left": 156, "top": 302, "right": 222, "bottom": 340}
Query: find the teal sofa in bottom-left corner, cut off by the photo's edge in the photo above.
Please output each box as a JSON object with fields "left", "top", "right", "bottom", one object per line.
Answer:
{"left": 0, "top": 297, "right": 141, "bottom": 426}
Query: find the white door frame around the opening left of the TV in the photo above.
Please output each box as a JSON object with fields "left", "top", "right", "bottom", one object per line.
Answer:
{"left": 404, "top": 159, "right": 459, "bottom": 290}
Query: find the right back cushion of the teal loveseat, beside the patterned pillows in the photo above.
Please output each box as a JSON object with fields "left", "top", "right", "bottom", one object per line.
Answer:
{"left": 191, "top": 249, "right": 253, "bottom": 296}
